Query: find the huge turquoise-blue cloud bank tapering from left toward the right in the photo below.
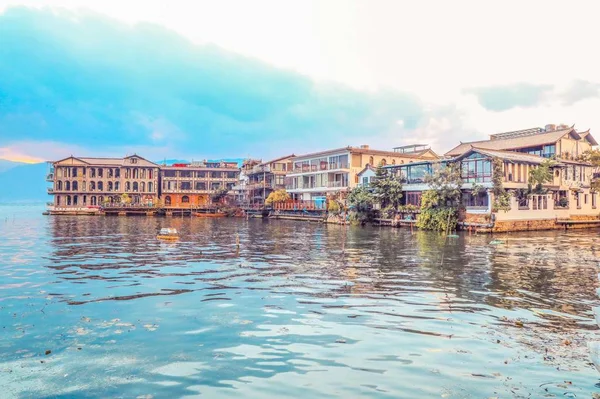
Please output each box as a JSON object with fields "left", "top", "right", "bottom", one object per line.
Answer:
{"left": 0, "top": 8, "right": 434, "bottom": 158}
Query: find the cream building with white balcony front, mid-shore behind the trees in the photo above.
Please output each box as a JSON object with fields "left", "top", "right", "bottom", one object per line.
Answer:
{"left": 286, "top": 145, "right": 439, "bottom": 200}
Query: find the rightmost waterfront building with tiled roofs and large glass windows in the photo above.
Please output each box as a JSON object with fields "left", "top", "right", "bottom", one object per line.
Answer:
{"left": 388, "top": 125, "right": 598, "bottom": 230}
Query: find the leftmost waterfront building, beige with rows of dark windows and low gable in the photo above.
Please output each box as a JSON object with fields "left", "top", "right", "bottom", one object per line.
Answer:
{"left": 47, "top": 155, "right": 159, "bottom": 210}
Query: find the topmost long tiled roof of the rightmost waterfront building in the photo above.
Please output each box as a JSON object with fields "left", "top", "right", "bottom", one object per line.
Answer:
{"left": 446, "top": 128, "right": 580, "bottom": 156}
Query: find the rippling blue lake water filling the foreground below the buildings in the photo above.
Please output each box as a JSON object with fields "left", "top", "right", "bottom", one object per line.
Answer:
{"left": 0, "top": 206, "right": 600, "bottom": 398}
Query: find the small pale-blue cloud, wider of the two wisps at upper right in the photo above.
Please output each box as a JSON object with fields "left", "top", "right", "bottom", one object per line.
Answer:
{"left": 464, "top": 83, "right": 553, "bottom": 112}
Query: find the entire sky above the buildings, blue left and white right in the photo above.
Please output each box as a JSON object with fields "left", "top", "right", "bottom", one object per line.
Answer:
{"left": 0, "top": 0, "right": 600, "bottom": 162}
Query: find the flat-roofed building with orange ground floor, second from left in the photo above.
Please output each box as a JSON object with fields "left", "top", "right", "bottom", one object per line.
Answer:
{"left": 160, "top": 161, "right": 240, "bottom": 208}
